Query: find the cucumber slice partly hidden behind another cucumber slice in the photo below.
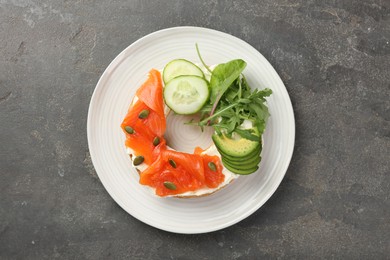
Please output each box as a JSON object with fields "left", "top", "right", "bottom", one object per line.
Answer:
{"left": 163, "top": 59, "right": 204, "bottom": 84}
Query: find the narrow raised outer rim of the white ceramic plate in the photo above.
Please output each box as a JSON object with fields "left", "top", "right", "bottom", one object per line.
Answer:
{"left": 87, "top": 26, "right": 296, "bottom": 234}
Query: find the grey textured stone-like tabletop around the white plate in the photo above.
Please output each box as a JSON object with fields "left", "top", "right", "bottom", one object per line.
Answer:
{"left": 0, "top": 0, "right": 390, "bottom": 259}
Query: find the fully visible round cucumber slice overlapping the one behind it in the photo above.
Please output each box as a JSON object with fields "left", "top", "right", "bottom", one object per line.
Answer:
{"left": 164, "top": 76, "right": 210, "bottom": 115}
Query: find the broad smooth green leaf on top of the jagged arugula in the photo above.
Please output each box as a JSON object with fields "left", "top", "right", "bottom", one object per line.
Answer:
{"left": 210, "top": 59, "right": 246, "bottom": 104}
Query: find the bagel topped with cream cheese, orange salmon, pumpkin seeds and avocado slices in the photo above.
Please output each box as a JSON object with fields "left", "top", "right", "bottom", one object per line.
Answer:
{"left": 121, "top": 62, "right": 263, "bottom": 198}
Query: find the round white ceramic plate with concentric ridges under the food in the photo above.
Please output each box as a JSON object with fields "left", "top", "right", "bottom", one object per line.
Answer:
{"left": 88, "top": 27, "right": 295, "bottom": 234}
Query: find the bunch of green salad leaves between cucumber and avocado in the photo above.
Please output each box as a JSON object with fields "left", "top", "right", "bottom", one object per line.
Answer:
{"left": 193, "top": 45, "right": 272, "bottom": 138}
